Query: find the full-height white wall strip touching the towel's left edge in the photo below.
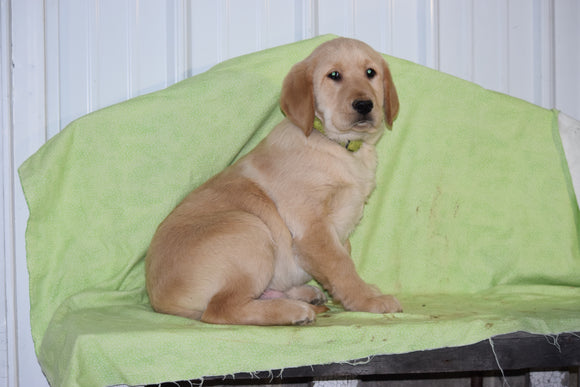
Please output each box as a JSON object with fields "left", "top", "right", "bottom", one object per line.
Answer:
{"left": 10, "top": 0, "right": 47, "bottom": 387}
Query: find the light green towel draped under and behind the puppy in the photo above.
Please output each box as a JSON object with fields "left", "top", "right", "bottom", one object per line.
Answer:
{"left": 20, "top": 36, "right": 580, "bottom": 386}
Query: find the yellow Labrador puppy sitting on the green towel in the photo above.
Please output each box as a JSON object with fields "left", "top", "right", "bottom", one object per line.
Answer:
{"left": 146, "top": 38, "right": 401, "bottom": 325}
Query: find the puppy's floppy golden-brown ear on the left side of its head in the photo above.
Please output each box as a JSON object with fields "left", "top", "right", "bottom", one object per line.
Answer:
{"left": 280, "top": 61, "right": 314, "bottom": 136}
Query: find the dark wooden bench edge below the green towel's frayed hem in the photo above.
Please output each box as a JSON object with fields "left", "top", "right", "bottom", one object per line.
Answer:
{"left": 151, "top": 332, "right": 580, "bottom": 386}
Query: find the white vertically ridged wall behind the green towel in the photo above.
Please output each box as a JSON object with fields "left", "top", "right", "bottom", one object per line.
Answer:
{"left": 0, "top": 0, "right": 580, "bottom": 386}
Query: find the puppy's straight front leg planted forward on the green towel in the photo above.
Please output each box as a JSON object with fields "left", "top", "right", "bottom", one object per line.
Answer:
{"left": 295, "top": 227, "right": 402, "bottom": 313}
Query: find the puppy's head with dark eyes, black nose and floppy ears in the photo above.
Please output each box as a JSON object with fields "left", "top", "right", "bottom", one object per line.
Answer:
{"left": 280, "top": 38, "right": 399, "bottom": 141}
